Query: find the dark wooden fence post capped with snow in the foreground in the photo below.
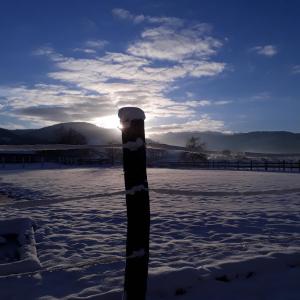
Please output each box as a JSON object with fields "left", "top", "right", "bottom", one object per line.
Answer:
{"left": 119, "top": 107, "right": 150, "bottom": 300}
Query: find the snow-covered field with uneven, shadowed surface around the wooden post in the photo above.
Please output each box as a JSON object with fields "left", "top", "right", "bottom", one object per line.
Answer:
{"left": 0, "top": 168, "right": 300, "bottom": 300}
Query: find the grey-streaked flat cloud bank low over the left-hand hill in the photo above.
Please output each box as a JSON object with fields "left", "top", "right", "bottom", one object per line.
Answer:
{"left": 0, "top": 84, "right": 117, "bottom": 124}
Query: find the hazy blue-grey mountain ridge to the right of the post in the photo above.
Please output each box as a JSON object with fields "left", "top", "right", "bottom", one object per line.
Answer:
{"left": 151, "top": 131, "right": 300, "bottom": 153}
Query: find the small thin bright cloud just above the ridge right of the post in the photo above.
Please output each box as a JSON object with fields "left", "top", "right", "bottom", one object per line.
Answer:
{"left": 147, "top": 115, "right": 225, "bottom": 135}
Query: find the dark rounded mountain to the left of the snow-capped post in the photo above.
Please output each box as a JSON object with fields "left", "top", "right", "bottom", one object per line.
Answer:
{"left": 0, "top": 122, "right": 121, "bottom": 145}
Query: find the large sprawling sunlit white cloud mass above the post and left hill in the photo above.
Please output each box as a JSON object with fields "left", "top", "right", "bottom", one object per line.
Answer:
{"left": 0, "top": 9, "right": 226, "bottom": 126}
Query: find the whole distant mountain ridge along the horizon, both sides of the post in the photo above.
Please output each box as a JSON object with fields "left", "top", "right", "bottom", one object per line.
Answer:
{"left": 0, "top": 122, "right": 300, "bottom": 154}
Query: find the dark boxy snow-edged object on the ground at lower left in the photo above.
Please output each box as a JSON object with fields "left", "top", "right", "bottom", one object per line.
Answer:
{"left": 0, "top": 218, "right": 41, "bottom": 276}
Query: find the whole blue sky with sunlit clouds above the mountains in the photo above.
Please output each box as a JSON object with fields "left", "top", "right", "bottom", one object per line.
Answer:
{"left": 0, "top": 0, "right": 300, "bottom": 134}
